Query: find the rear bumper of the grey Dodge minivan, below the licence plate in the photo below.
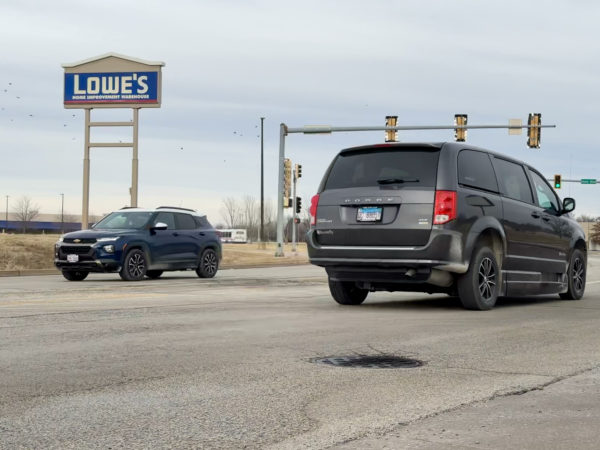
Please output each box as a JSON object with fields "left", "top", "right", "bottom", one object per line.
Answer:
{"left": 306, "top": 228, "right": 468, "bottom": 276}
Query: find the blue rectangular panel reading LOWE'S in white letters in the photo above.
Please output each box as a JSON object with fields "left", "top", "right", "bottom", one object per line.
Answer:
{"left": 64, "top": 72, "right": 158, "bottom": 105}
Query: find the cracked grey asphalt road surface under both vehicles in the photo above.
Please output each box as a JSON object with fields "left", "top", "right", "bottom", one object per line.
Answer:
{"left": 0, "top": 257, "right": 600, "bottom": 449}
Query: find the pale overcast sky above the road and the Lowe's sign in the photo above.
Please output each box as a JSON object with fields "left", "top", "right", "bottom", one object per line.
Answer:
{"left": 0, "top": 0, "right": 600, "bottom": 223}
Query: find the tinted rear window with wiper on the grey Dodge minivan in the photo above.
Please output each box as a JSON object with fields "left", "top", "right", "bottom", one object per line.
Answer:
{"left": 325, "top": 148, "right": 440, "bottom": 190}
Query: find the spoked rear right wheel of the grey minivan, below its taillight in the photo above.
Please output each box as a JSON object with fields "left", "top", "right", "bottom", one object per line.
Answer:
{"left": 457, "top": 246, "right": 501, "bottom": 311}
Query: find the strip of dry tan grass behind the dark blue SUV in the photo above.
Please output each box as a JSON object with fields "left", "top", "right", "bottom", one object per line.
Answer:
{"left": 0, "top": 234, "right": 308, "bottom": 270}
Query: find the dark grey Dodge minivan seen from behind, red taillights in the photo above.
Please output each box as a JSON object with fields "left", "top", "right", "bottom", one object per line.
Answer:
{"left": 307, "top": 142, "right": 587, "bottom": 310}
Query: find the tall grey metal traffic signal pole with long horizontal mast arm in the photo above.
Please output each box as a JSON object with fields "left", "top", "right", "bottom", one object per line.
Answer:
{"left": 275, "top": 118, "right": 556, "bottom": 256}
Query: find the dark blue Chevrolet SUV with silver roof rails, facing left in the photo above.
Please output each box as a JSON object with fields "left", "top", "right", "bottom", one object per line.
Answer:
{"left": 54, "top": 206, "right": 222, "bottom": 281}
